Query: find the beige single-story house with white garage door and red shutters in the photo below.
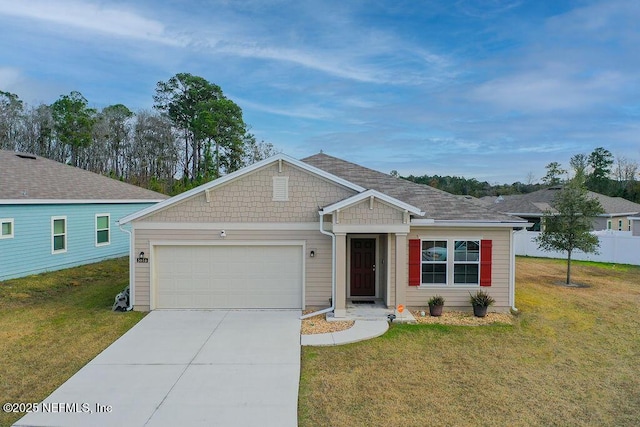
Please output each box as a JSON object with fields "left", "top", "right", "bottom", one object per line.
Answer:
{"left": 120, "top": 153, "right": 528, "bottom": 317}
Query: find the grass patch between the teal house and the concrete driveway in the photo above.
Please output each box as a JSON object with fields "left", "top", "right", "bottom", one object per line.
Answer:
{"left": 0, "top": 257, "right": 144, "bottom": 426}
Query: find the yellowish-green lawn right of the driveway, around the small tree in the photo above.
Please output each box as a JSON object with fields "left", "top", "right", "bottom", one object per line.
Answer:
{"left": 299, "top": 258, "right": 640, "bottom": 427}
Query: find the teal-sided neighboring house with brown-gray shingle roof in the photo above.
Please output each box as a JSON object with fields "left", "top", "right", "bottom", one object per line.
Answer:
{"left": 0, "top": 150, "right": 167, "bottom": 281}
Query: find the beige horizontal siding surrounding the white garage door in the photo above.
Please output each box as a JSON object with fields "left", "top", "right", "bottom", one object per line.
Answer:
{"left": 134, "top": 229, "right": 331, "bottom": 311}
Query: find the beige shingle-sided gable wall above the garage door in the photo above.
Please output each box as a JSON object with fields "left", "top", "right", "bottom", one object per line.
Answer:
{"left": 140, "top": 162, "right": 355, "bottom": 223}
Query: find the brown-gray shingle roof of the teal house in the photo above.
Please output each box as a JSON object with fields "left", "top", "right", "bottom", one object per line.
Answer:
{"left": 0, "top": 150, "right": 168, "bottom": 204}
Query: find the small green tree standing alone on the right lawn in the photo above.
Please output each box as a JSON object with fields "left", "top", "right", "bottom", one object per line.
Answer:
{"left": 536, "top": 174, "right": 604, "bottom": 285}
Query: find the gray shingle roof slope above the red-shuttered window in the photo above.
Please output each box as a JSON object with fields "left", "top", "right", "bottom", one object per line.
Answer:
{"left": 302, "top": 153, "right": 520, "bottom": 222}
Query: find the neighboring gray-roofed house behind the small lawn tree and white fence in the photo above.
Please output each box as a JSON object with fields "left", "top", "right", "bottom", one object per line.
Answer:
{"left": 481, "top": 185, "right": 640, "bottom": 231}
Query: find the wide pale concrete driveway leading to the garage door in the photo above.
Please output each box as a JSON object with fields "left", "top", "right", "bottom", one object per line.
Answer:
{"left": 15, "top": 310, "right": 300, "bottom": 426}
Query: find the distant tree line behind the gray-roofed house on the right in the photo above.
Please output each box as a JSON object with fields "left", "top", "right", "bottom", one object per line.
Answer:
{"left": 402, "top": 147, "right": 640, "bottom": 203}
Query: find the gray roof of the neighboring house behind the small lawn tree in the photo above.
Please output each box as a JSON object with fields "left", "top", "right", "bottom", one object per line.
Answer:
{"left": 482, "top": 186, "right": 640, "bottom": 216}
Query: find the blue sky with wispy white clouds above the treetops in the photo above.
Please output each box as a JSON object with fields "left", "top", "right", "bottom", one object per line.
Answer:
{"left": 0, "top": 0, "right": 640, "bottom": 183}
